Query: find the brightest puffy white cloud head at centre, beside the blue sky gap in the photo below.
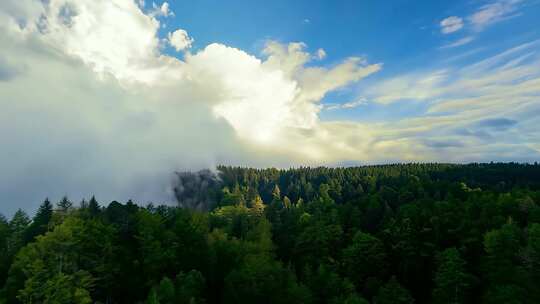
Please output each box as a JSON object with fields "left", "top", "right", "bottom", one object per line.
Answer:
{"left": 209, "top": 41, "right": 380, "bottom": 143}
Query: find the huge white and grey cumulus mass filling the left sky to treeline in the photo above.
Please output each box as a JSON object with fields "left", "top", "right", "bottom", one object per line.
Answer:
{"left": 0, "top": 0, "right": 380, "bottom": 213}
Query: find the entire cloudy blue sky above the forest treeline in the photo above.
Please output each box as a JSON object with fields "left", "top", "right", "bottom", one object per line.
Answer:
{"left": 0, "top": 0, "right": 540, "bottom": 215}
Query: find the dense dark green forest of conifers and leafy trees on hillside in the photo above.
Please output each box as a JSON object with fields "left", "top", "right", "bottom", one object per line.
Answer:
{"left": 0, "top": 163, "right": 540, "bottom": 304}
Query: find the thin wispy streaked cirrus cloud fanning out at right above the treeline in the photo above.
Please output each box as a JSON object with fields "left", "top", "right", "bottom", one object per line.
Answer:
{"left": 364, "top": 41, "right": 540, "bottom": 161}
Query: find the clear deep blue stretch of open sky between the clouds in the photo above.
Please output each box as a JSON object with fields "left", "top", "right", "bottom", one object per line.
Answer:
{"left": 146, "top": 0, "right": 540, "bottom": 121}
